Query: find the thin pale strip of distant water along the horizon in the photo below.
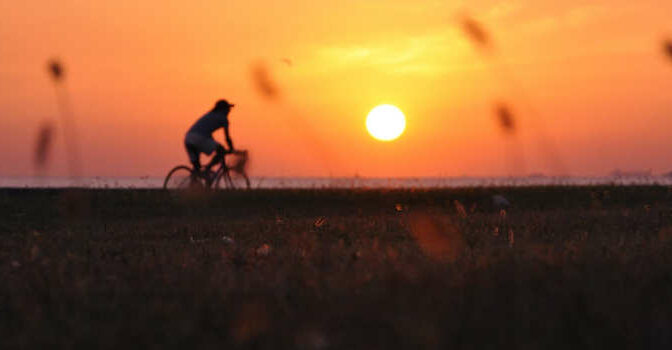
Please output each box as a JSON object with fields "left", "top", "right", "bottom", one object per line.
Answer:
{"left": 0, "top": 176, "right": 672, "bottom": 189}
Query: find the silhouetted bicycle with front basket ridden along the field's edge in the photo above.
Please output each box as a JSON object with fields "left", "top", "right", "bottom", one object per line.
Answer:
{"left": 163, "top": 151, "right": 250, "bottom": 190}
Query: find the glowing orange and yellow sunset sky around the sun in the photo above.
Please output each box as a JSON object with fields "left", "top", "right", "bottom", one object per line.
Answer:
{"left": 0, "top": 0, "right": 672, "bottom": 177}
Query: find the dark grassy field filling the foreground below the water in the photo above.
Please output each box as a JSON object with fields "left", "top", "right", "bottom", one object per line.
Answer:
{"left": 0, "top": 187, "right": 672, "bottom": 349}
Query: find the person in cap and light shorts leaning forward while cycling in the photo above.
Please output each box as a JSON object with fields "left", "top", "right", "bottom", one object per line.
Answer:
{"left": 184, "top": 100, "right": 235, "bottom": 173}
